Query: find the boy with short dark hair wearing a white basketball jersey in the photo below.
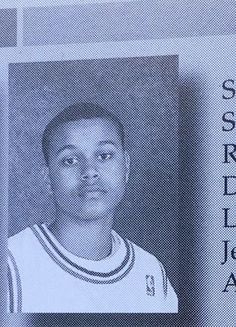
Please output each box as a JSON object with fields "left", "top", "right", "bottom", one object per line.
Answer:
{"left": 8, "top": 103, "right": 177, "bottom": 312}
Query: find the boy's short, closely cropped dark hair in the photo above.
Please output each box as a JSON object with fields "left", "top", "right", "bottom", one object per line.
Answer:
{"left": 42, "top": 102, "right": 125, "bottom": 165}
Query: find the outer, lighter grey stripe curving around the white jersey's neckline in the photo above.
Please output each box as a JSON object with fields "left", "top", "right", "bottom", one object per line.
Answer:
{"left": 31, "top": 226, "right": 135, "bottom": 284}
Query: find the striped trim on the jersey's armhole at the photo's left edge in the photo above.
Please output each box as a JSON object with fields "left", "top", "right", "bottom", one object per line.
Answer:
{"left": 8, "top": 250, "right": 22, "bottom": 312}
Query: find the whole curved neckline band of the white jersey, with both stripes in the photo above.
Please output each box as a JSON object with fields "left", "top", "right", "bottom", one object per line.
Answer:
{"left": 31, "top": 224, "right": 135, "bottom": 284}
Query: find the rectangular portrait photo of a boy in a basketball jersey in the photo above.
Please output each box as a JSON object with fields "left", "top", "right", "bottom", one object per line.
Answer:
{"left": 8, "top": 55, "right": 179, "bottom": 313}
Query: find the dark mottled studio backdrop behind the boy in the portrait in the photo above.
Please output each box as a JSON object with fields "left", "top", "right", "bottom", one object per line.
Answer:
{"left": 9, "top": 56, "right": 178, "bottom": 289}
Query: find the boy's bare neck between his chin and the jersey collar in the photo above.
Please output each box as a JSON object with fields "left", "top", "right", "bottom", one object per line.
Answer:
{"left": 49, "top": 212, "right": 113, "bottom": 260}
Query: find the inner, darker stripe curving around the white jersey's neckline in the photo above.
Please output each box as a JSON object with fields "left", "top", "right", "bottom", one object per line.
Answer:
{"left": 38, "top": 226, "right": 130, "bottom": 277}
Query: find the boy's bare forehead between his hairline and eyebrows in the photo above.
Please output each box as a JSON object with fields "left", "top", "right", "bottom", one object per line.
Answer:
{"left": 50, "top": 118, "right": 121, "bottom": 149}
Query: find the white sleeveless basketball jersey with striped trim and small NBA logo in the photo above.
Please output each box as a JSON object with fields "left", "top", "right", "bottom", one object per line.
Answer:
{"left": 8, "top": 224, "right": 178, "bottom": 313}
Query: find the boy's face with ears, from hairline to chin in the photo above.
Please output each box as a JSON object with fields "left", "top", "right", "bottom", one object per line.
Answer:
{"left": 44, "top": 118, "right": 129, "bottom": 219}
